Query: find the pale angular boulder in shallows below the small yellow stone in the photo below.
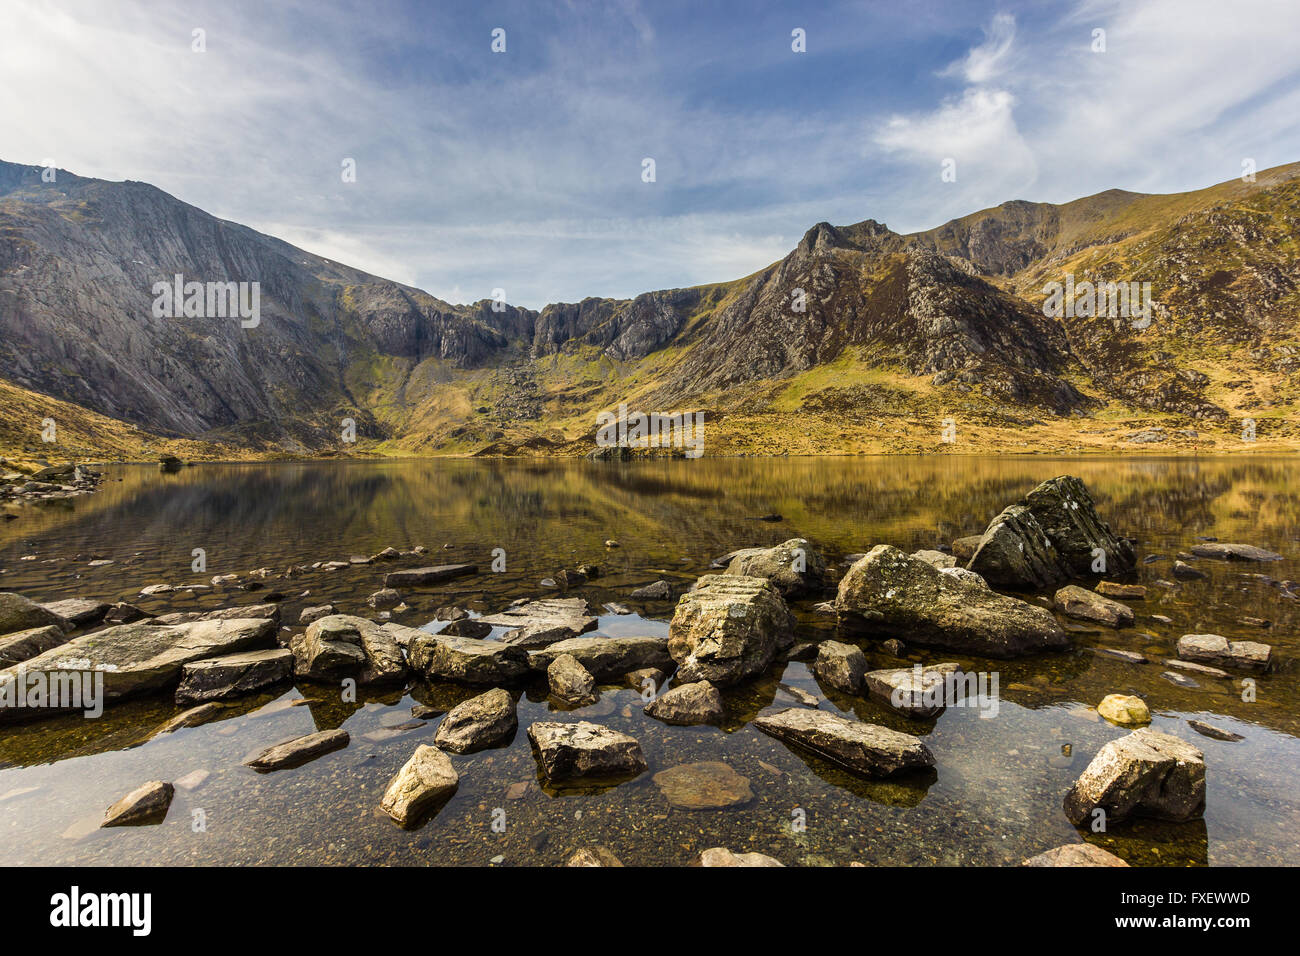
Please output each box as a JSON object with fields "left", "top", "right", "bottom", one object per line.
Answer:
{"left": 1065, "top": 728, "right": 1205, "bottom": 826}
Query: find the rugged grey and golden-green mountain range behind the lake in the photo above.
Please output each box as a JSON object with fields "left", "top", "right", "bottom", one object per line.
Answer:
{"left": 0, "top": 163, "right": 1300, "bottom": 454}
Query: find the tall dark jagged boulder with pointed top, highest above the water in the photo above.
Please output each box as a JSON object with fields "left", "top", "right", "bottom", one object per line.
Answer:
{"left": 966, "top": 475, "right": 1138, "bottom": 591}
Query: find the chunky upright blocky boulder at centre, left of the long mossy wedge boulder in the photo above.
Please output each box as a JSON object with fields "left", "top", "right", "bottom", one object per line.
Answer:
{"left": 668, "top": 574, "right": 794, "bottom": 685}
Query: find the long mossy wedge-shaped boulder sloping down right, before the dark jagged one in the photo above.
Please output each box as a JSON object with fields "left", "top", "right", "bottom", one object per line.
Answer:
{"left": 835, "top": 545, "right": 1070, "bottom": 658}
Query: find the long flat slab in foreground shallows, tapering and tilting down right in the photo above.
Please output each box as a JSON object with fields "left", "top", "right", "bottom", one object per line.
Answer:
{"left": 754, "top": 708, "right": 935, "bottom": 778}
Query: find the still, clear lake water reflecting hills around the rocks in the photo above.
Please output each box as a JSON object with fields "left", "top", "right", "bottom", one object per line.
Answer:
{"left": 0, "top": 457, "right": 1300, "bottom": 865}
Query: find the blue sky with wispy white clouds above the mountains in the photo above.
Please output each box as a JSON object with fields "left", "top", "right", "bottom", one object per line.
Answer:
{"left": 0, "top": 0, "right": 1300, "bottom": 308}
